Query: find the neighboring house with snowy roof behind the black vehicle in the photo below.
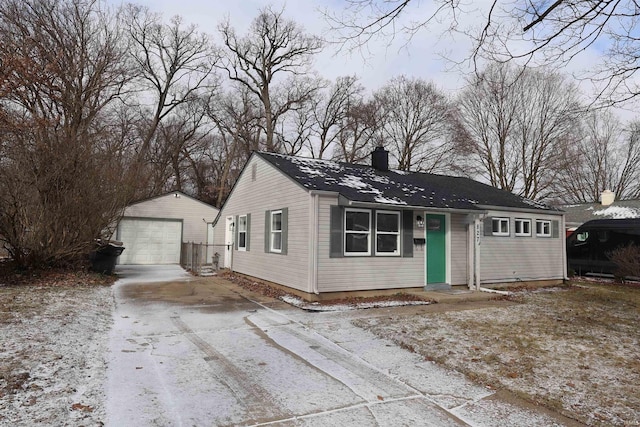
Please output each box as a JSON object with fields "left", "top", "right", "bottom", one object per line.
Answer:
{"left": 559, "top": 190, "right": 640, "bottom": 235}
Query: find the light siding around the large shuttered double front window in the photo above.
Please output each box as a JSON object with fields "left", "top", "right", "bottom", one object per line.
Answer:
{"left": 317, "top": 197, "right": 425, "bottom": 293}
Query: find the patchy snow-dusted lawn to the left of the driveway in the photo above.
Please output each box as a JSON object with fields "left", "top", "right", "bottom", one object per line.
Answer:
{"left": 0, "top": 284, "right": 114, "bottom": 426}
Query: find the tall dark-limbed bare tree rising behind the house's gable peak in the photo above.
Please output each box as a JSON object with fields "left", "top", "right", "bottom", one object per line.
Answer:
{"left": 219, "top": 8, "right": 322, "bottom": 151}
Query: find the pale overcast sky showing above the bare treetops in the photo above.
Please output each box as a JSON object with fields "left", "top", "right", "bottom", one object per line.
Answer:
{"left": 108, "top": 0, "right": 633, "bottom": 119}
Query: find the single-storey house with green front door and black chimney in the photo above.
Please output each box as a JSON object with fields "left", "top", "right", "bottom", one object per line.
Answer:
{"left": 213, "top": 149, "right": 566, "bottom": 294}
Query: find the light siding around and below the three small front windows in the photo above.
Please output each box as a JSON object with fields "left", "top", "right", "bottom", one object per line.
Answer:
{"left": 480, "top": 211, "right": 564, "bottom": 283}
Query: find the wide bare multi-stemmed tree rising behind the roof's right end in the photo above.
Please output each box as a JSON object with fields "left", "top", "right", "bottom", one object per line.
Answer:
{"left": 458, "top": 64, "right": 580, "bottom": 199}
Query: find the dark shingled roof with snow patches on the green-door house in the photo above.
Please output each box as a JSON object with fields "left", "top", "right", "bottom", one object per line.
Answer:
{"left": 256, "top": 152, "right": 560, "bottom": 212}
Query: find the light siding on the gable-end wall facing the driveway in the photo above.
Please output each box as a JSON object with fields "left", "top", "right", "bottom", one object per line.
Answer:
{"left": 214, "top": 156, "right": 310, "bottom": 292}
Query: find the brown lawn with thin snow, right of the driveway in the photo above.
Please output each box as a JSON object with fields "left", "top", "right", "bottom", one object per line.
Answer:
{"left": 355, "top": 283, "right": 640, "bottom": 426}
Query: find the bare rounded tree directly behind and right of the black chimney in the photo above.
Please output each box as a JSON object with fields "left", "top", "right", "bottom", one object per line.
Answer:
{"left": 374, "top": 76, "right": 455, "bottom": 173}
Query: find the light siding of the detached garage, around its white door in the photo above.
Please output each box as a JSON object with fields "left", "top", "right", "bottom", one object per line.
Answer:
{"left": 119, "top": 193, "right": 218, "bottom": 243}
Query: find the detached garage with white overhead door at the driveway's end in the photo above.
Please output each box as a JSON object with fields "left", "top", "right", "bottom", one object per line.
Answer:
{"left": 115, "top": 191, "right": 219, "bottom": 264}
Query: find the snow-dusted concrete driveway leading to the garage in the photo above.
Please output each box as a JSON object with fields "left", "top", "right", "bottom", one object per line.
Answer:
{"left": 107, "top": 266, "right": 576, "bottom": 426}
